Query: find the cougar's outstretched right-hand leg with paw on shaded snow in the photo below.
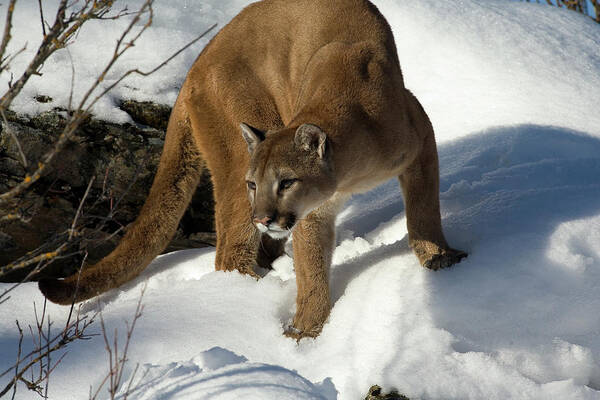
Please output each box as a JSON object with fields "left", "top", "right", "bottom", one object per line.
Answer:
{"left": 399, "top": 91, "right": 467, "bottom": 270}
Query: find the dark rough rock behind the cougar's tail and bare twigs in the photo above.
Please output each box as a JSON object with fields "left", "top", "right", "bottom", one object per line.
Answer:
{"left": 0, "top": 96, "right": 215, "bottom": 281}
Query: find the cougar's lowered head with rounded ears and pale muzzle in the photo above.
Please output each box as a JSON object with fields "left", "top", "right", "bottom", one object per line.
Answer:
{"left": 240, "top": 124, "right": 336, "bottom": 239}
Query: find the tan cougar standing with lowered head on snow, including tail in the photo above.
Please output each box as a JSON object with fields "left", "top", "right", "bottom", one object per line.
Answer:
{"left": 40, "top": 0, "right": 466, "bottom": 338}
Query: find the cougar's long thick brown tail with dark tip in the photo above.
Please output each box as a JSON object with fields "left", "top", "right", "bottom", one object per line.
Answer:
{"left": 39, "top": 100, "right": 204, "bottom": 304}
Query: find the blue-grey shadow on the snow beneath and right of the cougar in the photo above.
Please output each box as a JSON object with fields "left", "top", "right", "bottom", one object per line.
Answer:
{"left": 332, "top": 125, "right": 600, "bottom": 387}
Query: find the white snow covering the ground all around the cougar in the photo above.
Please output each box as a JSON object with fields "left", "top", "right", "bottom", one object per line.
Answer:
{"left": 0, "top": 0, "right": 600, "bottom": 400}
